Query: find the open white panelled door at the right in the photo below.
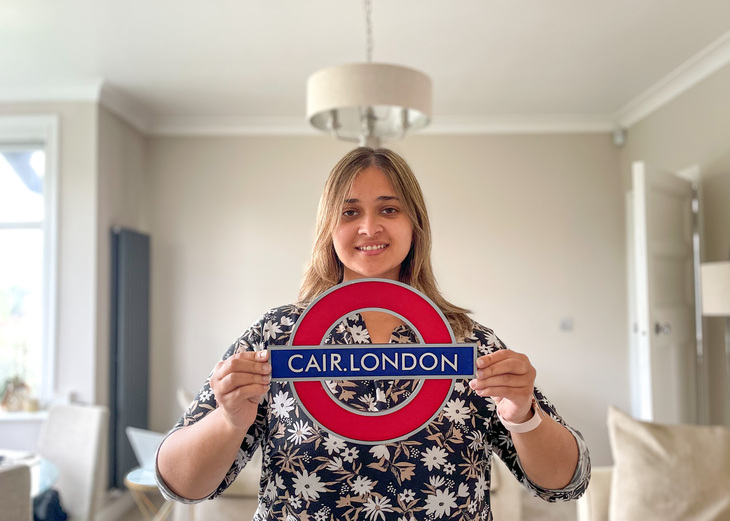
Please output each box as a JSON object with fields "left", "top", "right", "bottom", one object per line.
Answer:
{"left": 629, "top": 162, "right": 697, "bottom": 423}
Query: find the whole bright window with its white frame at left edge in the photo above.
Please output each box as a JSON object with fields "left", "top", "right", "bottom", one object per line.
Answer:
{"left": 0, "top": 116, "right": 57, "bottom": 411}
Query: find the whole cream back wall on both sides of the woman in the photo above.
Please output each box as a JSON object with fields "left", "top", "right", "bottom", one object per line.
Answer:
{"left": 149, "top": 135, "right": 629, "bottom": 464}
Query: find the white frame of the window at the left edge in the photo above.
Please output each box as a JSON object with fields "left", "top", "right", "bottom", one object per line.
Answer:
{"left": 0, "top": 114, "right": 60, "bottom": 406}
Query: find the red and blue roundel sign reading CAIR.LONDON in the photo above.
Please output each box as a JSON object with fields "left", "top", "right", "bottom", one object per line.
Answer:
{"left": 269, "top": 279, "right": 476, "bottom": 444}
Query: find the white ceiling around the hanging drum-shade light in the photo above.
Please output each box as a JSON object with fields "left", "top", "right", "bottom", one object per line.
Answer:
{"left": 0, "top": 0, "right": 730, "bottom": 134}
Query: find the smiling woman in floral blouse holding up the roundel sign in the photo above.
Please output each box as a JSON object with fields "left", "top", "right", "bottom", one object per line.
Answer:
{"left": 157, "top": 148, "right": 590, "bottom": 521}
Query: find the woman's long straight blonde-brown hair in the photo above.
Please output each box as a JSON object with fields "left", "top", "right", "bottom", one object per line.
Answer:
{"left": 299, "top": 147, "right": 472, "bottom": 338}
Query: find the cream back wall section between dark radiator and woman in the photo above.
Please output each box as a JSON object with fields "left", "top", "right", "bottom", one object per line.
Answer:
{"left": 148, "top": 138, "right": 348, "bottom": 424}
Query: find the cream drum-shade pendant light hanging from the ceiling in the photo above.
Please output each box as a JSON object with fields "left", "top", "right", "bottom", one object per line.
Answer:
{"left": 307, "top": 0, "right": 431, "bottom": 148}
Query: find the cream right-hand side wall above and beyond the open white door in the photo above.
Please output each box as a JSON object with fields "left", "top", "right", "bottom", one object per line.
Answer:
{"left": 621, "top": 62, "right": 730, "bottom": 425}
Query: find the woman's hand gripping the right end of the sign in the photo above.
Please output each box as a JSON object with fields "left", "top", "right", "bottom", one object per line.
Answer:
{"left": 469, "top": 349, "right": 537, "bottom": 423}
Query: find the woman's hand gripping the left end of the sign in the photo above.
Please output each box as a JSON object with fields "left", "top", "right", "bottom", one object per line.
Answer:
{"left": 210, "top": 350, "right": 271, "bottom": 429}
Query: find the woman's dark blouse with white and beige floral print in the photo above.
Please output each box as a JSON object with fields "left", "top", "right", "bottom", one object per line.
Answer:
{"left": 157, "top": 305, "right": 590, "bottom": 521}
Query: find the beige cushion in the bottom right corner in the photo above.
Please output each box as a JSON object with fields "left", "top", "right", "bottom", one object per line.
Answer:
{"left": 608, "top": 407, "right": 730, "bottom": 521}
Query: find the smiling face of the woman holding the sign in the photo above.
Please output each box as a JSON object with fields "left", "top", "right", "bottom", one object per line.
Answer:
{"left": 332, "top": 166, "right": 413, "bottom": 281}
